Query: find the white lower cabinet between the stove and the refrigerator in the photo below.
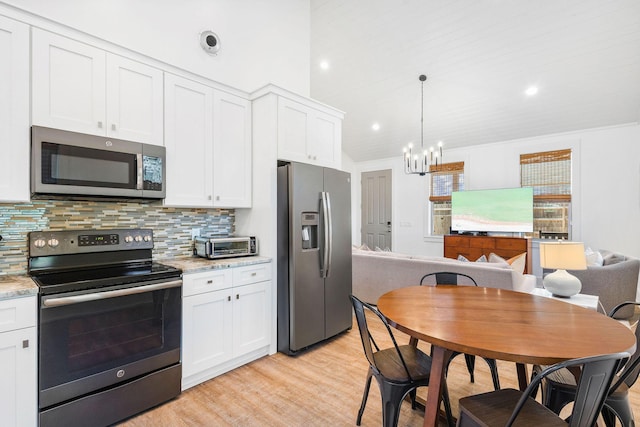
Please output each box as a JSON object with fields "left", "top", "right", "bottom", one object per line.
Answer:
{"left": 182, "top": 263, "right": 271, "bottom": 390}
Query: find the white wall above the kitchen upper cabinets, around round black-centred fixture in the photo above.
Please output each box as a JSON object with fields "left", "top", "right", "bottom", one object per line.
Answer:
{"left": 0, "top": 0, "right": 310, "bottom": 96}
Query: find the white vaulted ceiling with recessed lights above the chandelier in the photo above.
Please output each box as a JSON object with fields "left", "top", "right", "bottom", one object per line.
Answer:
{"left": 311, "top": 0, "right": 640, "bottom": 161}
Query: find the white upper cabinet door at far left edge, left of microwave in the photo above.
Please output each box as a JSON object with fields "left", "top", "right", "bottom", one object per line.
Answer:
{"left": 0, "top": 16, "right": 30, "bottom": 201}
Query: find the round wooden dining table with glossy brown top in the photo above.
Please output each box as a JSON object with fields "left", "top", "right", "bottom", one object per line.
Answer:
{"left": 378, "top": 285, "right": 636, "bottom": 426}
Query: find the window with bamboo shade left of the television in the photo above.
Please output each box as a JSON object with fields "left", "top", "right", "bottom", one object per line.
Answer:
{"left": 429, "top": 162, "right": 464, "bottom": 235}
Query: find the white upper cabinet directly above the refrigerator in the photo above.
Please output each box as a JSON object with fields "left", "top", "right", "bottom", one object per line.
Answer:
{"left": 278, "top": 96, "right": 342, "bottom": 168}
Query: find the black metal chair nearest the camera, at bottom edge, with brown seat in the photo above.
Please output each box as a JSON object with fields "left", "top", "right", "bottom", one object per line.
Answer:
{"left": 457, "top": 353, "right": 629, "bottom": 427}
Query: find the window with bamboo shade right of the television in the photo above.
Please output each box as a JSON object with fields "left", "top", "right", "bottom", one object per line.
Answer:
{"left": 520, "top": 149, "right": 571, "bottom": 239}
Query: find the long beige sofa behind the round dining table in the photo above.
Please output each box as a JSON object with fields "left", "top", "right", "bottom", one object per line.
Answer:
{"left": 352, "top": 249, "right": 536, "bottom": 304}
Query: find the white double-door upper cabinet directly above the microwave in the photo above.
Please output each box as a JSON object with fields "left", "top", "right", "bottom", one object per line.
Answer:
{"left": 32, "top": 28, "right": 163, "bottom": 145}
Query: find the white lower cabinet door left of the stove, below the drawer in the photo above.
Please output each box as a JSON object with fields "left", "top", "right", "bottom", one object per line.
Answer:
{"left": 0, "top": 328, "right": 38, "bottom": 426}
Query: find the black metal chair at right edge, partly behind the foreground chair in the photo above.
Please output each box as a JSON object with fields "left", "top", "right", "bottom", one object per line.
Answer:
{"left": 532, "top": 301, "right": 640, "bottom": 427}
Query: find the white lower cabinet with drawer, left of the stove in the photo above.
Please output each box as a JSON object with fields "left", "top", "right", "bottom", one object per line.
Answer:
{"left": 0, "top": 296, "right": 38, "bottom": 426}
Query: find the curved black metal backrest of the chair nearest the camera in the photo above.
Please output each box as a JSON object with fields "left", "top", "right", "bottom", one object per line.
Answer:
{"left": 506, "top": 353, "right": 629, "bottom": 427}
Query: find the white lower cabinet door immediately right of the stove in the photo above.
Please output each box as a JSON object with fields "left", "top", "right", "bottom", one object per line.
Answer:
{"left": 182, "top": 289, "right": 233, "bottom": 378}
